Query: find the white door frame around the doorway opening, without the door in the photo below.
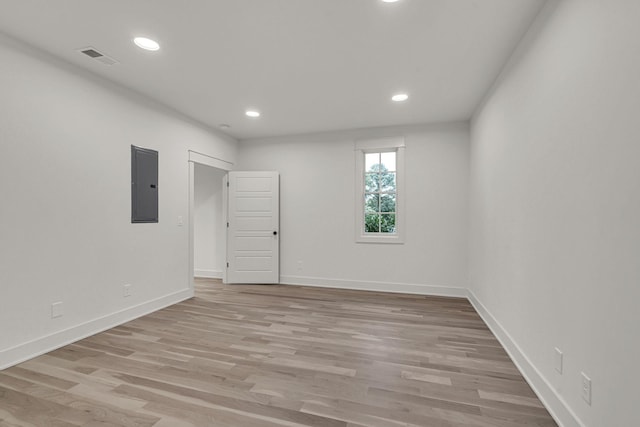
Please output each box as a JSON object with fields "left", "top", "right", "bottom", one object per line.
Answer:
{"left": 187, "top": 150, "right": 234, "bottom": 293}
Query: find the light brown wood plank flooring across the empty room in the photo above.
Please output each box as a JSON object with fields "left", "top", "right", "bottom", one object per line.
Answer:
{"left": 0, "top": 280, "right": 556, "bottom": 427}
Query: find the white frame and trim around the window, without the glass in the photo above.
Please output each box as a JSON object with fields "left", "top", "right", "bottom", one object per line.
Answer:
{"left": 354, "top": 136, "right": 406, "bottom": 244}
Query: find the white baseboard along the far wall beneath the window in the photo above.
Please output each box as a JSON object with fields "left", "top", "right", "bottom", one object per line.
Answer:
{"left": 280, "top": 276, "right": 467, "bottom": 298}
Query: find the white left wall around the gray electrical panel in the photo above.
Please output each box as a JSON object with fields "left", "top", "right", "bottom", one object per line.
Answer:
{"left": 0, "top": 32, "right": 236, "bottom": 368}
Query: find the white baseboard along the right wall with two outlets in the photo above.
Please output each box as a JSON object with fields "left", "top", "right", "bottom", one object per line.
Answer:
{"left": 468, "top": 290, "right": 584, "bottom": 427}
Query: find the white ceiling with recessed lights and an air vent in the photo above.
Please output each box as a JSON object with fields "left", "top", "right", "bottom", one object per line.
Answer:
{"left": 0, "top": 0, "right": 544, "bottom": 139}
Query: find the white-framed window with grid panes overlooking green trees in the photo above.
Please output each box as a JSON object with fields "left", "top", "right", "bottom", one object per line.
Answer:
{"left": 355, "top": 137, "right": 405, "bottom": 243}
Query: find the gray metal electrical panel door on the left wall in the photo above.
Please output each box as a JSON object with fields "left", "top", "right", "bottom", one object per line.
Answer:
{"left": 131, "top": 145, "right": 158, "bottom": 223}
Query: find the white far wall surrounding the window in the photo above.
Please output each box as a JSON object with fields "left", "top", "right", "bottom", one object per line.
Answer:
{"left": 238, "top": 124, "right": 469, "bottom": 295}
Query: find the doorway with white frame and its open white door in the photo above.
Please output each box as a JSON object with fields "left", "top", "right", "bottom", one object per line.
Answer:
{"left": 188, "top": 151, "right": 280, "bottom": 291}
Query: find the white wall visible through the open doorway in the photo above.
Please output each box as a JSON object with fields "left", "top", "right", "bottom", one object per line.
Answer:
{"left": 193, "top": 164, "right": 226, "bottom": 278}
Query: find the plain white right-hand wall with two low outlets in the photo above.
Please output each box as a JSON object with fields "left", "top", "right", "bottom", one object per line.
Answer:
{"left": 470, "top": 0, "right": 640, "bottom": 427}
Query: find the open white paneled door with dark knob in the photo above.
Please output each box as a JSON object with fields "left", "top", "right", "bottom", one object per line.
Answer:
{"left": 225, "top": 172, "right": 280, "bottom": 284}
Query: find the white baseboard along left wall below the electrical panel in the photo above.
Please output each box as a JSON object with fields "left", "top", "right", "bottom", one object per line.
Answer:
{"left": 0, "top": 289, "right": 193, "bottom": 370}
